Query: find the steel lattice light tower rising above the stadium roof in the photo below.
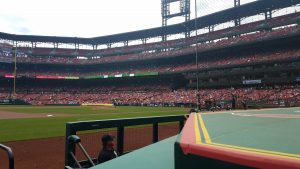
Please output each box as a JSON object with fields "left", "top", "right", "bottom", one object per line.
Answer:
{"left": 161, "top": 0, "right": 191, "bottom": 41}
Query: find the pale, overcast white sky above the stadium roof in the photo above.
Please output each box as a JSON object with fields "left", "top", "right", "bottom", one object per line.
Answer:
{"left": 0, "top": 0, "right": 254, "bottom": 37}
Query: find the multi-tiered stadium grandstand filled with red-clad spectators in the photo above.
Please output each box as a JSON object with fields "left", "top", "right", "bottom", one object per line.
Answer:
{"left": 0, "top": 0, "right": 300, "bottom": 169}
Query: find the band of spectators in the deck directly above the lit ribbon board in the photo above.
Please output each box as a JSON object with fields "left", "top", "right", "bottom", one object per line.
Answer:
{"left": 0, "top": 49, "right": 300, "bottom": 77}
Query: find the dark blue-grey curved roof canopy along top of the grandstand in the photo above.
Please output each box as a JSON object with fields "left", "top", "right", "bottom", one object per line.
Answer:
{"left": 0, "top": 0, "right": 300, "bottom": 45}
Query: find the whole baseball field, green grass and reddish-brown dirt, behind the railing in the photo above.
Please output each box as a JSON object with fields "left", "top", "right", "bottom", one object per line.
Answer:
{"left": 0, "top": 105, "right": 189, "bottom": 169}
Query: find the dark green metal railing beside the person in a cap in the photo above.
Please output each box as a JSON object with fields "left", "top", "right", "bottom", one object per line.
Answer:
{"left": 65, "top": 115, "right": 185, "bottom": 167}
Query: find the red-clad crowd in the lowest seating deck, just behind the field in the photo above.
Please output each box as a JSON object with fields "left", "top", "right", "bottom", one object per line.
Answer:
{"left": 0, "top": 85, "right": 300, "bottom": 108}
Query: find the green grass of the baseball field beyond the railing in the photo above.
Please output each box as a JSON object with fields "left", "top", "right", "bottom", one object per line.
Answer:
{"left": 0, "top": 106, "right": 188, "bottom": 142}
